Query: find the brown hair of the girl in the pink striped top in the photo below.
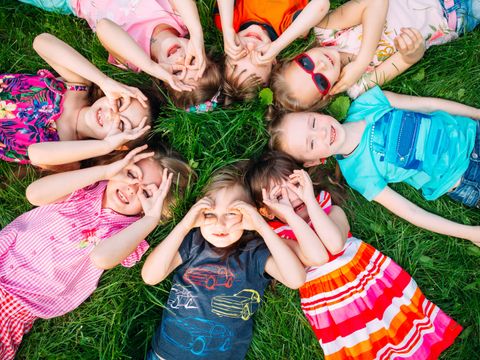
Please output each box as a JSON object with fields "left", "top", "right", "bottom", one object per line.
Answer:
{"left": 93, "top": 139, "right": 197, "bottom": 221}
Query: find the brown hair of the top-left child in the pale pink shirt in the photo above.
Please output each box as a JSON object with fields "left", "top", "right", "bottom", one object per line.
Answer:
{"left": 165, "top": 56, "right": 222, "bottom": 109}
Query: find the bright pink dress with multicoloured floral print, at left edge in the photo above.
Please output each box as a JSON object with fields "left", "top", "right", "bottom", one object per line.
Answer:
{"left": 0, "top": 70, "right": 88, "bottom": 164}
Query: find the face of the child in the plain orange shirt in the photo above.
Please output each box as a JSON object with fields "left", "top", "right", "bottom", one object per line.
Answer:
{"left": 225, "top": 25, "right": 274, "bottom": 84}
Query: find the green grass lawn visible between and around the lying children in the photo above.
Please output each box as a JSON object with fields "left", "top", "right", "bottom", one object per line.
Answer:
{"left": 0, "top": 0, "right": 480, "bottom": 360}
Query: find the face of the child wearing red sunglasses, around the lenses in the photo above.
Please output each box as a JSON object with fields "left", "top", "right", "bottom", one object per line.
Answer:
{"left": 284, "top": 47, "right": 341, "bottom": 106}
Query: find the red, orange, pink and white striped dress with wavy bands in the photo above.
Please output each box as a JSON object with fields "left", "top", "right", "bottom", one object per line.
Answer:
{"left": 271, "top": 192, "right": 462, "bottom": 360}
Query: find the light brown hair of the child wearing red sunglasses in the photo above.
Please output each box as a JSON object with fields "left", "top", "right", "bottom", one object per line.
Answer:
{"left": 270, "top": 60, "right": 332, "bottom": 111}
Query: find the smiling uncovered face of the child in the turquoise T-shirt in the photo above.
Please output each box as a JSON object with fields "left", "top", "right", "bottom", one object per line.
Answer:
{"left": 280, "top": 112, "right": 345, "bottom": 167}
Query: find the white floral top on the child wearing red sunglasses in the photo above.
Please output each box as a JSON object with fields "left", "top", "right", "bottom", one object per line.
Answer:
{"left": 314, "top": 0, "right": 458, "bottom": 98}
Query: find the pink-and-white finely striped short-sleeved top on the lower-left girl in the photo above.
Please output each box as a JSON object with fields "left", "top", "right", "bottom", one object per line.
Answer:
{"left": 0, "top": 181, "right": 148, "bottom": 319}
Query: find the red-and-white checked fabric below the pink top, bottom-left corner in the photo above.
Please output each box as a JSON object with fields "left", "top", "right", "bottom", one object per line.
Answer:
{"left": 0, "top": 287, "right": 35, "bottom": 360}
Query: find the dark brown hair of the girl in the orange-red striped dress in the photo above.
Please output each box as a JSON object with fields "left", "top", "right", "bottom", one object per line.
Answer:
{"left": 245, "top": 150, "right": 346, "bottom": 208}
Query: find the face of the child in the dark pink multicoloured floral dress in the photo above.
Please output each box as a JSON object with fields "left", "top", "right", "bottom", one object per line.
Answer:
{"left": 83, "top": 96, "right": 150, "bottom": 139}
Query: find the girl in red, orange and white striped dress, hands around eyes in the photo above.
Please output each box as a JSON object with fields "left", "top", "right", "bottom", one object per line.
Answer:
{"left": 246, "top": 151, "right": 462, "bottom": 360}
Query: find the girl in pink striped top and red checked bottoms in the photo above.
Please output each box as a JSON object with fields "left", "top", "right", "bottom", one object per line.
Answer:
{"left": 0, "top": 145, "right": 195, "bottom": 360}
